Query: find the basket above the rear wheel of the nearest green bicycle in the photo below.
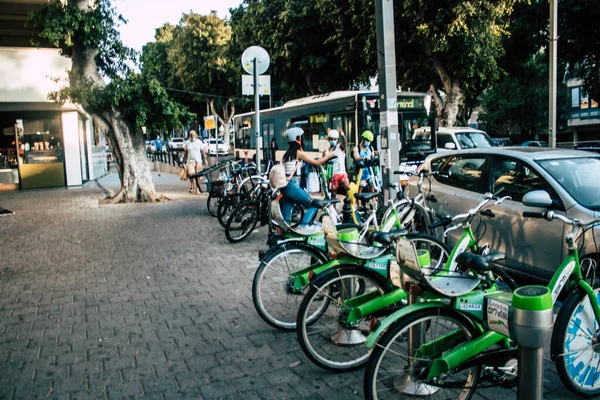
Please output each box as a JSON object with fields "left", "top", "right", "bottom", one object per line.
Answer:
{"left": 396, "top": 238, "right": 480, "bottom": 297}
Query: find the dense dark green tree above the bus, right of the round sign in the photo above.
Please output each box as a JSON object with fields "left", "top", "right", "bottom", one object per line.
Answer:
{"left": 230, "top": 0, "right": 370, "bottom": 98}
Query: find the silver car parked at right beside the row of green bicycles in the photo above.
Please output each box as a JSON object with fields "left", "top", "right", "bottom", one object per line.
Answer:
{"left": 407, "top": 147, "right": 600, "bottom": 283}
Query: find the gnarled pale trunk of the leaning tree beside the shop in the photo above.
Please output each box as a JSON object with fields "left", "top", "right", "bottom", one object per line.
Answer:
{"left": 69, "top": 0, "right": 158, "bottom": 203}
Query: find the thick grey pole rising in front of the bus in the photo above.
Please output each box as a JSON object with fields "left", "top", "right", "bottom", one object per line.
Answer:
{"left": 375, "top": 0, "right": 400, "bottom": 201}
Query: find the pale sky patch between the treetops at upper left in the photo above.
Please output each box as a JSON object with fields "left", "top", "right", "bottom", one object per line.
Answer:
{"left": 113, "top": 0, "right": 242, "bottom": 51}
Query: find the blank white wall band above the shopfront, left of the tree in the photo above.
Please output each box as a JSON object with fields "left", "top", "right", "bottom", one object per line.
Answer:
{"left": 0, "top": 47, "right": 71, "bottom": 102}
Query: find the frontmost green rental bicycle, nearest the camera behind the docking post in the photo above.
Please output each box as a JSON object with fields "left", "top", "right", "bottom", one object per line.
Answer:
{"left": 364, "top": 190, "right": 600, "bottom": 399}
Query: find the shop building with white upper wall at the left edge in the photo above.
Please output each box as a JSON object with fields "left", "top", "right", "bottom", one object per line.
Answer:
{"left": 0, "top": 0, "right": 107, "bottom": 189}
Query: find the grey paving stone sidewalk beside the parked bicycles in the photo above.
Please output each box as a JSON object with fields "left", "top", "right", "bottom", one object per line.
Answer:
{"left": 0, "top": 173, "right": 596, "bottom": 400}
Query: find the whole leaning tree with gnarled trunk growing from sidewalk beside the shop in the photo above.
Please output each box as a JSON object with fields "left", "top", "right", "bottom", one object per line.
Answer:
{"left": 29, "top": 0, "right": 189, "bottom": 202}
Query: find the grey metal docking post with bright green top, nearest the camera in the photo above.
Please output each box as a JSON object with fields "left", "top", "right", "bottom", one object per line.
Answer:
{"left": 509, "top": 286, "right": 553, "bottom": 400}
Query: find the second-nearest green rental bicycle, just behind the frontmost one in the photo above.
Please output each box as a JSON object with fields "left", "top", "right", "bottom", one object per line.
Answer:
{"left": 296, "top": 194, "right": 516, "bottom": 371}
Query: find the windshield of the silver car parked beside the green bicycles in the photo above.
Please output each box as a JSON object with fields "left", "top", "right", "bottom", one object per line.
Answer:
{"left": 538, "top": 157, "right": 600, "bottom": 210}
